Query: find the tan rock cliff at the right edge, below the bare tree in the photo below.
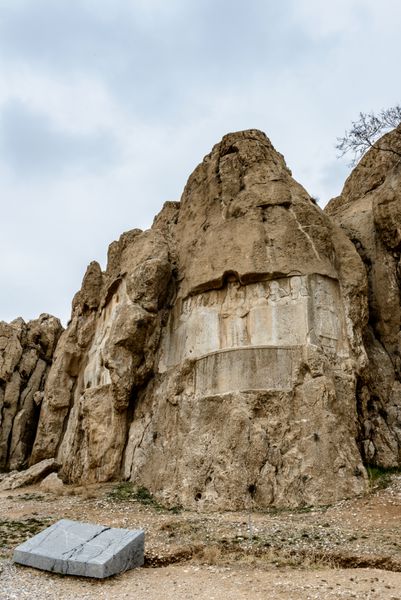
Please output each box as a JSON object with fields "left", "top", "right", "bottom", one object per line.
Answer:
{"left": 326, "top": 127, "right": 401, "bottom": 467}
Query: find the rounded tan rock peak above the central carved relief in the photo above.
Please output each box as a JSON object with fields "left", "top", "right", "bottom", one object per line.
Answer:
{"left": 176, "top": 130, "right": 336, "bottom": 297}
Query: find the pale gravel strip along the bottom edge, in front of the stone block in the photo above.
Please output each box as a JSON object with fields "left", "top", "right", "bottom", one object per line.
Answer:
{"left": 0, "top": 562, "right": 401, "bottom": 600}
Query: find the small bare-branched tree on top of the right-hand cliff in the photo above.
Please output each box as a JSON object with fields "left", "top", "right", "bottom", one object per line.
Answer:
{"left": 336, "top": 104, "right": 401, "bottom": 165}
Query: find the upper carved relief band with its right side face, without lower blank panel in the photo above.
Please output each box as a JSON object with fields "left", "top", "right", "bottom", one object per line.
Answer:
{"left": 159, "top": 275, "right": 345, "bottom": 372}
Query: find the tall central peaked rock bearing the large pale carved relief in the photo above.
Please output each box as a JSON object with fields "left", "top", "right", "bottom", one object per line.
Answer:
{"left": 123, "top": 130, "right": 367, "bottom": 509}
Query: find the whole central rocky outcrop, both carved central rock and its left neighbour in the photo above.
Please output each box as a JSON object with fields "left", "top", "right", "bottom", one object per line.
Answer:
{"left": 31, "top": 130, "right": 368, "bottom": 509}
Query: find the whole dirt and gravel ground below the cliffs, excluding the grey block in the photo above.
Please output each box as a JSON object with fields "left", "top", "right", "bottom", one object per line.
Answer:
{"left": 0, "top": 475, "right": 401, "bottom": 600}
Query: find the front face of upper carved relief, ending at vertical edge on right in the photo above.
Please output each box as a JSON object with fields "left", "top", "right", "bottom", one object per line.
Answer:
{"left": 159, "top": 276, "right": 309, "bottom": 371}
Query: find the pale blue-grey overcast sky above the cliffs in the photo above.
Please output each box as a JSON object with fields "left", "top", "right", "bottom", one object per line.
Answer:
{"left": 0, "top": 0, "right": 401, "bottom": 323}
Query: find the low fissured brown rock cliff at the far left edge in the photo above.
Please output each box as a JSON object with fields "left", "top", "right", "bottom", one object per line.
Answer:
{"left": 0, "top": 314, "right": 62, "bottom": 470}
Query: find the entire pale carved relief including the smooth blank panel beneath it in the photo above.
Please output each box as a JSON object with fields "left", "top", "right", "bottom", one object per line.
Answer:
{"left": 159, "top": 275, "right": 348, "bottom": 394}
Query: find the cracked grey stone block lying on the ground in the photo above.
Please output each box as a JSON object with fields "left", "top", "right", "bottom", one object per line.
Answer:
{"left": 13, "top": 519, "right": 145, "bottom": 579}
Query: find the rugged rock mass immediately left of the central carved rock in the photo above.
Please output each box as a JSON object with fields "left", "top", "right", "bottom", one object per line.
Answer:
{"left": 31, "top": 230, "right": 171, "bottom": 481}
